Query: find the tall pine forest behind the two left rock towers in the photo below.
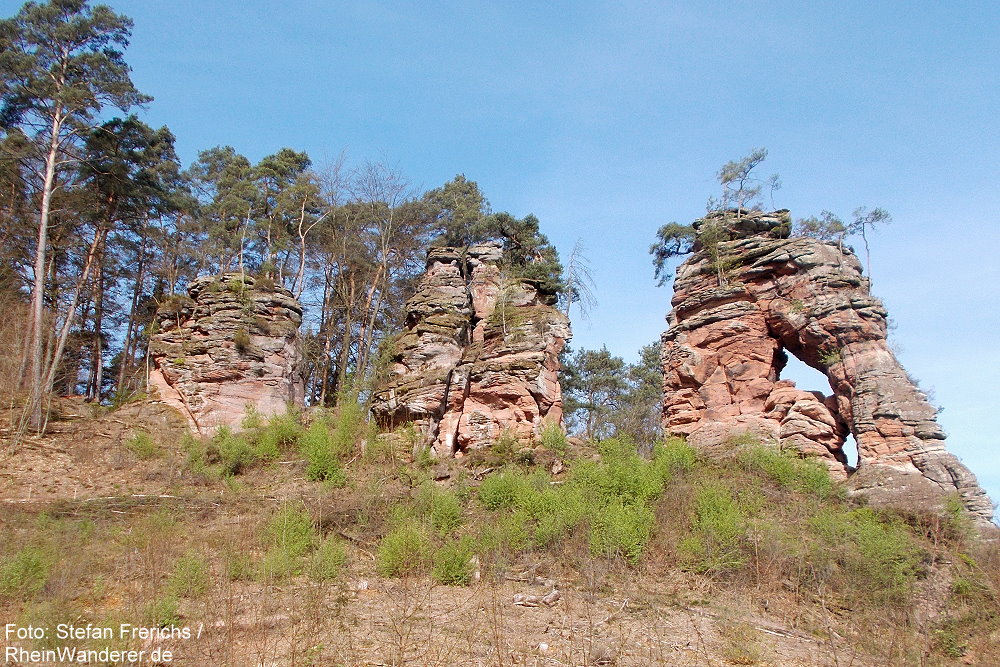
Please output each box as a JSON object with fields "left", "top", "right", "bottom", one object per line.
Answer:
{"left": 0, "top": 0, "right": 575, "bottom": 434}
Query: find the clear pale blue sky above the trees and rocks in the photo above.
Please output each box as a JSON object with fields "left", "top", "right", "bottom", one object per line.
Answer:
{"left": 0, "top": 0, "right": 1000, "bottom": 506}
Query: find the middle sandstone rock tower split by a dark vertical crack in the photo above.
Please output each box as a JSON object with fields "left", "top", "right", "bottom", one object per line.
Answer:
{"left": 372, "top": 243, "right": 570, "bottom": 456}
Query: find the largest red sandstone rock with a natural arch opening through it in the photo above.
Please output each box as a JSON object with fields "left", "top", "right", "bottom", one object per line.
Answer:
{"left": 662, "top": 211, "right": 993, "bottom": 521}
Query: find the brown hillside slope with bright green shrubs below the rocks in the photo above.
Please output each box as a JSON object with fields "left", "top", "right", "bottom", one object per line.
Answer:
{"left": 0, "top": 403, "right": 1000, "bottom": 665}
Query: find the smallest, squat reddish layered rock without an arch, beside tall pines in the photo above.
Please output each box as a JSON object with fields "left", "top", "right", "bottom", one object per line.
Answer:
{"left": 149, "top": 273, "right": 303, "bottom": 434}
